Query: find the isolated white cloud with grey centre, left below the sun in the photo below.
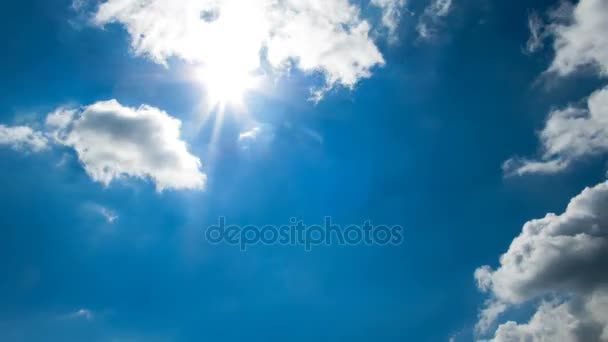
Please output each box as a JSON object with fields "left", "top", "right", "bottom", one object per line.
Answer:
{"left": 47, "top": 100, "right": 206, "bottom": 191}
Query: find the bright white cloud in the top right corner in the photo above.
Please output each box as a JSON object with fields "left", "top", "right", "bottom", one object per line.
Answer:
{"left": 549, "top": 0, "right": 608, "bottom": 76}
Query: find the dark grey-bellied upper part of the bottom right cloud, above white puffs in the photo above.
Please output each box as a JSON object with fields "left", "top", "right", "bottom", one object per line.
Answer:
{"left": 476, "top": 183, "right": 608, "bottom": 303}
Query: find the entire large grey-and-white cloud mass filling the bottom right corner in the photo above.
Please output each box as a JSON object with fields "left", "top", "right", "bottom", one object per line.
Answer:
{"left": 475, "top": 183, "right": 608, "bottom": 342}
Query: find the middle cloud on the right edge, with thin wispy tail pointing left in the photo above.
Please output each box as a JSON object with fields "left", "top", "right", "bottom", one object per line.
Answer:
{"left": 504, "top": 87, "right": 608, "bottom": 175}
